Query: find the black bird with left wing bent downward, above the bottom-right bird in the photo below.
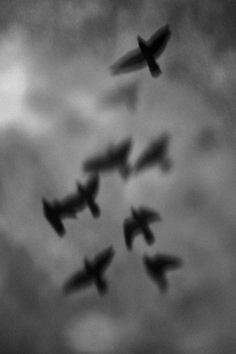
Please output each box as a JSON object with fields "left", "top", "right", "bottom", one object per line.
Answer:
{"left": 123, "top": 207, "right": 161, "bottom": 250}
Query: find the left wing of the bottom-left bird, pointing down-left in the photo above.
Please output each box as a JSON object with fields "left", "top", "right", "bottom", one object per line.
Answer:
{"left": 63, "top": 269, "right": 92, "bottom": 294}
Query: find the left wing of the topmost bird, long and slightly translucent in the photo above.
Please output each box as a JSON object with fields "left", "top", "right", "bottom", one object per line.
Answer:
{"left": 110, "top": 48, "right": 146, "bottom": 75}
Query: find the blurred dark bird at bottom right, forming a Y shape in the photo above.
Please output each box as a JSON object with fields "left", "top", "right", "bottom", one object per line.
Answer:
{"left": 143, "top": 254, "right": 183, "bottom": 293}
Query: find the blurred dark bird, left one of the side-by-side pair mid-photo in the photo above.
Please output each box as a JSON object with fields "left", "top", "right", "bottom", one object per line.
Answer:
{"left": 83, "top": 137, "right": 132, "bottom": 179}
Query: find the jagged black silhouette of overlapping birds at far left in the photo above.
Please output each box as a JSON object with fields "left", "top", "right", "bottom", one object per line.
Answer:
{"left": 42, "top": 175, "right": 100, "bottom": 237}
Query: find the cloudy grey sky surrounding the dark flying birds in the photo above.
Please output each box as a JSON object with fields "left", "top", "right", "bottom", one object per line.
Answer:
{"left": 0, "top": 0, "right": 236, "bottom": 354}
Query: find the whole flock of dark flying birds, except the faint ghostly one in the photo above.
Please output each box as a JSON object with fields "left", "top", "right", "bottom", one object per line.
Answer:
{"left": 42, "top": 25, "right": 182, "bottom": 294}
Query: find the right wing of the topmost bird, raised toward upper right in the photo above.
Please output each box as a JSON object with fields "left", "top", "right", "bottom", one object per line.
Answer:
{"left": 147, "top": 24, "right": 171, "bottom": 57}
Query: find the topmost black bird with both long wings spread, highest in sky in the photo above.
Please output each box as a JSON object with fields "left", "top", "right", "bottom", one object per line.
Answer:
{"left": 110, "top": 25, "right": 171, "bottom": 77}
